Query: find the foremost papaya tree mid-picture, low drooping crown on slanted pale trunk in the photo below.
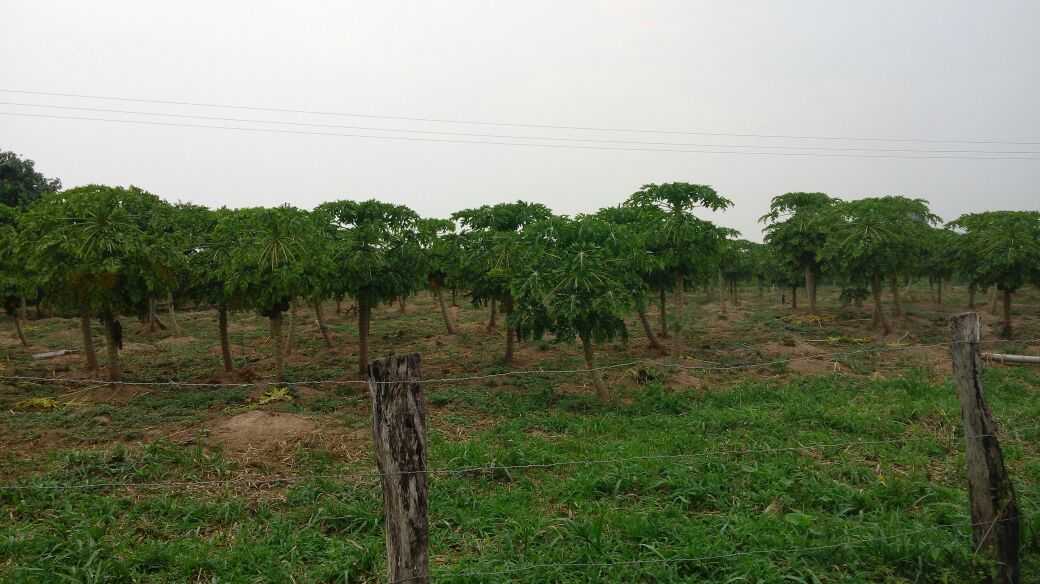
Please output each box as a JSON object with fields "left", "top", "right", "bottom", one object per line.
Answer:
{"left": 510, "top": 216, "right": 643, "bottom": 400}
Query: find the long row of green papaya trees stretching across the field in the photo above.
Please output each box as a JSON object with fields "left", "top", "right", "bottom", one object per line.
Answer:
{"left": 0, "top": 152, "right": 1040, "bottom": 397}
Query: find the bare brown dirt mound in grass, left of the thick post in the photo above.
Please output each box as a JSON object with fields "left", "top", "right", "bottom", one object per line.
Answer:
{"left": 208, "top": 409, "right": 318, "bottom": 452}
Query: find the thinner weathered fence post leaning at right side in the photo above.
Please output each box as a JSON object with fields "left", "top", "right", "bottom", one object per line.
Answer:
{"left": 950, "top": 313, "right": 1021, "bottom": 584}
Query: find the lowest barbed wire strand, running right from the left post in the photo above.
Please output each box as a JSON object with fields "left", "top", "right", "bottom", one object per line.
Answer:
{"left": 388, "top": 512, "right": 1040, "bottom": 584}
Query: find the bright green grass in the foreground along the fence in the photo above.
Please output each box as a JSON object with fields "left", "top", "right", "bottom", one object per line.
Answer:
{"left": 0, "top": 369, "right": 1040, "bottom": 583}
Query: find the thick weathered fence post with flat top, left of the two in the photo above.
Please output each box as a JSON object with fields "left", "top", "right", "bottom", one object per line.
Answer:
{"left": 368, "top": 353, "right": 430, "bottom": 584}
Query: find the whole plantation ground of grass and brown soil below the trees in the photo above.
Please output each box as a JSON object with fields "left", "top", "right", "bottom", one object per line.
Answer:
{"left": 0, "top": 287, "right": 1040, "bottom": 583}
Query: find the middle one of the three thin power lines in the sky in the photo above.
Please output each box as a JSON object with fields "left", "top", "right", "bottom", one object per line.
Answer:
{"left": 0, "top": 101, "right": 1040, "bottom": 155}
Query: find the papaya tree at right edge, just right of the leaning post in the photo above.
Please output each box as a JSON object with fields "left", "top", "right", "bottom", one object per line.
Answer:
{"left": 950, "top": 211, "right": 1040, "bottom": 339}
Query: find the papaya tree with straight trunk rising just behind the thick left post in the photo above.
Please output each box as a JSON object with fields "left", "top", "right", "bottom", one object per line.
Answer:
{"left": 315, "top": 200, "right": 419, "bottom": 375}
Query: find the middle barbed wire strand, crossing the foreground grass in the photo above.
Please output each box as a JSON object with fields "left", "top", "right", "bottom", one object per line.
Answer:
{"left": 0, "top": 424, "right": 1040, "bottom": 490}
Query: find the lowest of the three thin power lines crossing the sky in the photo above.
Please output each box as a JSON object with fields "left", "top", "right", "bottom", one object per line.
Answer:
{"left": 0, "top": 111, "right": 1040, "bottom": 160}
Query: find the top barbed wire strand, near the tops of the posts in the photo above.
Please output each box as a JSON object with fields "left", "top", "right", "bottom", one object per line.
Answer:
{"left": 0, "top": 339, "right": 1040, "bottom": 389}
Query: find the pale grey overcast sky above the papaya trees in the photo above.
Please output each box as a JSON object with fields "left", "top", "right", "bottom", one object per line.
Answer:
{"left": 0, "top": 0, "right": 1040, "bottom": 240}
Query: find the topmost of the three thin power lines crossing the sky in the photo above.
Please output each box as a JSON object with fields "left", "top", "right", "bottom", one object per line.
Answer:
{"left": 0, "top": 88, "right": 1040, "bottom": 145}
